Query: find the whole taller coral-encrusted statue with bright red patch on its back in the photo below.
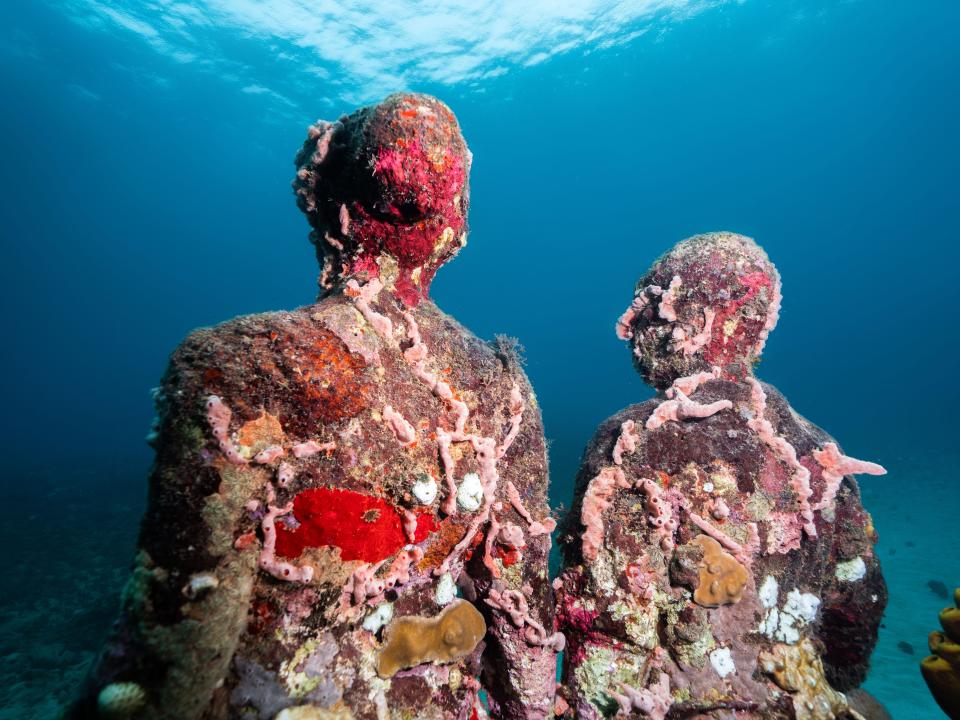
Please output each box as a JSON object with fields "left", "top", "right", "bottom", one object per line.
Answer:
{"left": 68, "top": 94, "right": 563, "bottom": 720}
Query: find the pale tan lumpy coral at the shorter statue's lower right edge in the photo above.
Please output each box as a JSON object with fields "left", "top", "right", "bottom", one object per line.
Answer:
{"left": 758, "top": 638, "right": 849, "bottom": 720}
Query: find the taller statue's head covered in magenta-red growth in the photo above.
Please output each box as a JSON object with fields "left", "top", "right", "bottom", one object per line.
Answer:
{"left": 293, "top": 93, "right": 471, "bottom": 305}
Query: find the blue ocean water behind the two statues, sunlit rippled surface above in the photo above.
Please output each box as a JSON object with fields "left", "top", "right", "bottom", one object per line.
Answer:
{"left": 0, "top": 0, "right": 960, "bottom": 720}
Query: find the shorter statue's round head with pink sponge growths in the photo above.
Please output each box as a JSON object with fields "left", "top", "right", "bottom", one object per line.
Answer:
{"left": 617, "top": 232, "right": 780, "bottom": 389}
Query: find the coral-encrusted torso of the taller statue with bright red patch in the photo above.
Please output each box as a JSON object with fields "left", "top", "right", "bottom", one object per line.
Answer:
{"left": 75, "top": 284, "right": 554, "bottom": 719}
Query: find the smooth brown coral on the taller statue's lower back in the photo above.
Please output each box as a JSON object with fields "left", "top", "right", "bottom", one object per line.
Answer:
{"left": 377, "top": 600, "right": 487, "bottom": 678}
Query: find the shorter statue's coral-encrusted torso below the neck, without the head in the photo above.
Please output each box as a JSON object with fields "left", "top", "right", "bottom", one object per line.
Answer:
{"left": 558, "top": 380, "right": 886, "bottom": 719}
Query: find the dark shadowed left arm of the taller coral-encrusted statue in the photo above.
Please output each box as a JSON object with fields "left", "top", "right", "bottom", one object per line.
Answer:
{"left": 68, "top": 331, "right": 267, "bottom": 720}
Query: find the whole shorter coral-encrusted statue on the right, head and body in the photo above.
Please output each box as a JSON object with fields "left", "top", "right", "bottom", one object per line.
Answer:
{"left": 554, "top": 233, "right": 887, "bottom": 720}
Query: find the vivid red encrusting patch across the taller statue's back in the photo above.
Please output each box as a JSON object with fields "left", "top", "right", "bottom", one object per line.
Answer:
{"left": 276, "top": 487, "right": 437, "bottom": 562}
